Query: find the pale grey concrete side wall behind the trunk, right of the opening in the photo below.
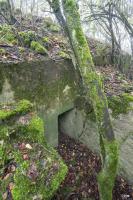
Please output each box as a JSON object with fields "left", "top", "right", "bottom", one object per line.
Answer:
{"left": 59, "top": 93, "right": 133, "bottom": 183}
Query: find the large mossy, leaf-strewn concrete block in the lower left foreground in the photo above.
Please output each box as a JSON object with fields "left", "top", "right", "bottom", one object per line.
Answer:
{"left": 0, "top": 100, "right": 67, "bottom": 200}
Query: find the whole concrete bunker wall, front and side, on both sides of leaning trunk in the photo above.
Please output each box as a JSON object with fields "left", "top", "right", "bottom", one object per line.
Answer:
{"left": 0, "top": 59, "right": 133, "bottom": 183}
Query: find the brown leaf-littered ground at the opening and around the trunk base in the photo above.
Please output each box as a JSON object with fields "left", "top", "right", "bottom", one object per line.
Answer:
{"left": 53, "top": 134, "right": 133, "bottom": 200}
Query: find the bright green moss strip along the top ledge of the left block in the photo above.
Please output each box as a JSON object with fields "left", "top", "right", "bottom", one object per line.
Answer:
{"left": 0, "top": 100, "right": 32, "bottom": 120}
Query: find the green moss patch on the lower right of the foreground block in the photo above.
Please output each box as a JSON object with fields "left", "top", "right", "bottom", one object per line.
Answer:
{"left": 12, "top": 149, "right": 67, "bottom": 200}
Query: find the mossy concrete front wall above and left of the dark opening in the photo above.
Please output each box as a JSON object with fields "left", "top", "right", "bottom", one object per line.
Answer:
{"left": 0, "top": 58, "right": 77, "bottom": 146}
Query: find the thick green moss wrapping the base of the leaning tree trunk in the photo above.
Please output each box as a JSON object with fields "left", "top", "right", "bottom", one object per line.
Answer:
{"left": 98, "top": 140, "right": 119, "bottom": 200}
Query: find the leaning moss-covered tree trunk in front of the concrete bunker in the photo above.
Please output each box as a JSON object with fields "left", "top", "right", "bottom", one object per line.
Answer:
{"left": 48, "top": 0, "right": 118, "bottom": 200}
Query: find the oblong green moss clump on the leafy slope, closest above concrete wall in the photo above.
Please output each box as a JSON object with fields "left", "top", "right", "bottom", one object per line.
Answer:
{"left": 31, "top": 41, "right": 48, "bottom": 55}
